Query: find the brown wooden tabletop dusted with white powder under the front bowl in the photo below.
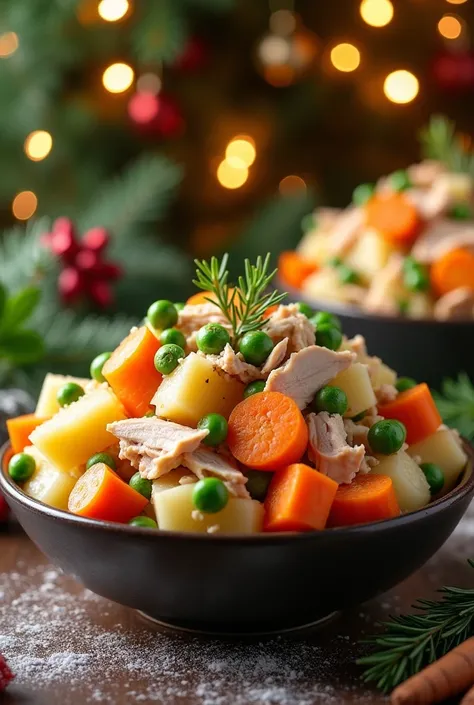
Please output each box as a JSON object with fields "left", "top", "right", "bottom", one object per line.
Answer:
{"left": 0, "top": 505, "right": 474, "bottom": 705}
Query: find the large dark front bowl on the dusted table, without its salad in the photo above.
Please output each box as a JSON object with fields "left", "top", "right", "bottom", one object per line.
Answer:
{"left": 0, "top": 443, "right": 474, "bottom": 634}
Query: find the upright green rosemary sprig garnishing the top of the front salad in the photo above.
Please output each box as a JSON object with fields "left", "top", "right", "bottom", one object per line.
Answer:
{"left": 193, "top": 254, "right": 286, "bottom": 345}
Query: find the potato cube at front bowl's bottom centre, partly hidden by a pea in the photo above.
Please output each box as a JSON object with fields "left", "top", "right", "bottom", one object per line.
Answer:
{"left": 154, "top": 485, "right": 264, "bottom": 534}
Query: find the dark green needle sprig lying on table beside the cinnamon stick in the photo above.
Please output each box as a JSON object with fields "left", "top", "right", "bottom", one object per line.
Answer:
{"left": 357, "top": 560, "right": 474, "bottom": 693}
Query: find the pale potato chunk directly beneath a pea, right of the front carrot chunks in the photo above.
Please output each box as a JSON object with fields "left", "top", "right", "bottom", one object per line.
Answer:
{"left": 372, "top": 450, "right": 431, "bottom": 512}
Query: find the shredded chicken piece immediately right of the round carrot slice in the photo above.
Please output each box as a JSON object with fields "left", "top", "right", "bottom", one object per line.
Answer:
{"left": 306, "top": 411, "right": 365, "bottom": 485}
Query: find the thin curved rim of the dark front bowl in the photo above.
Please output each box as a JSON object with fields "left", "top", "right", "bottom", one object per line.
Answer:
{"left": 0, "top": 438, "right": 474, "bottom": 544}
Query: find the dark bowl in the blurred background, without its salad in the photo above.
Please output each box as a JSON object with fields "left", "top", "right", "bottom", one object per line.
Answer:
{"left": 277, "top": 282, "right": 474, "bottom": 389}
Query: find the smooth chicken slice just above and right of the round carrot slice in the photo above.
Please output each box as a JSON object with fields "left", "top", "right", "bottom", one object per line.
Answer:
{"left": 265, "top": 345, "right": 355, "bottom": 409}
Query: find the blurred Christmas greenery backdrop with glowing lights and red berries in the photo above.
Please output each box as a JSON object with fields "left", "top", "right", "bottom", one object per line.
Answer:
{"left": 0, "top": 0, "right": 474, "bottom": 389}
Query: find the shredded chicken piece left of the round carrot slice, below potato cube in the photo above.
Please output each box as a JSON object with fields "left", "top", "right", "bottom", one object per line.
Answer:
{"left": 107, "top": 417, "right": 208, "bottom": 480}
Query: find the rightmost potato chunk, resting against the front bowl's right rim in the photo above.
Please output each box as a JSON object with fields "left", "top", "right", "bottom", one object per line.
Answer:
{"left": 408, "top": 428, "right": 467, "bottom": 493}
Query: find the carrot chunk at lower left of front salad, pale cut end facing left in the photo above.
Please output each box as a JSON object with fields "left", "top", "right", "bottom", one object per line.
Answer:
{"left": 68, "top": 463, "right": 148, "bottom": 524}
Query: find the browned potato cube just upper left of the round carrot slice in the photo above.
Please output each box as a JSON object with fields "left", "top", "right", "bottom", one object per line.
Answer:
{"left": 151, "top": 353, "right": 244, "bottom": 427}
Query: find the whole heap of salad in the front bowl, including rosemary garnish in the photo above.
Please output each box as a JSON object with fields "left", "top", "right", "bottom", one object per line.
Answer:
{"left": 2, "top": 256, "right": 467, "bottom": 537}
